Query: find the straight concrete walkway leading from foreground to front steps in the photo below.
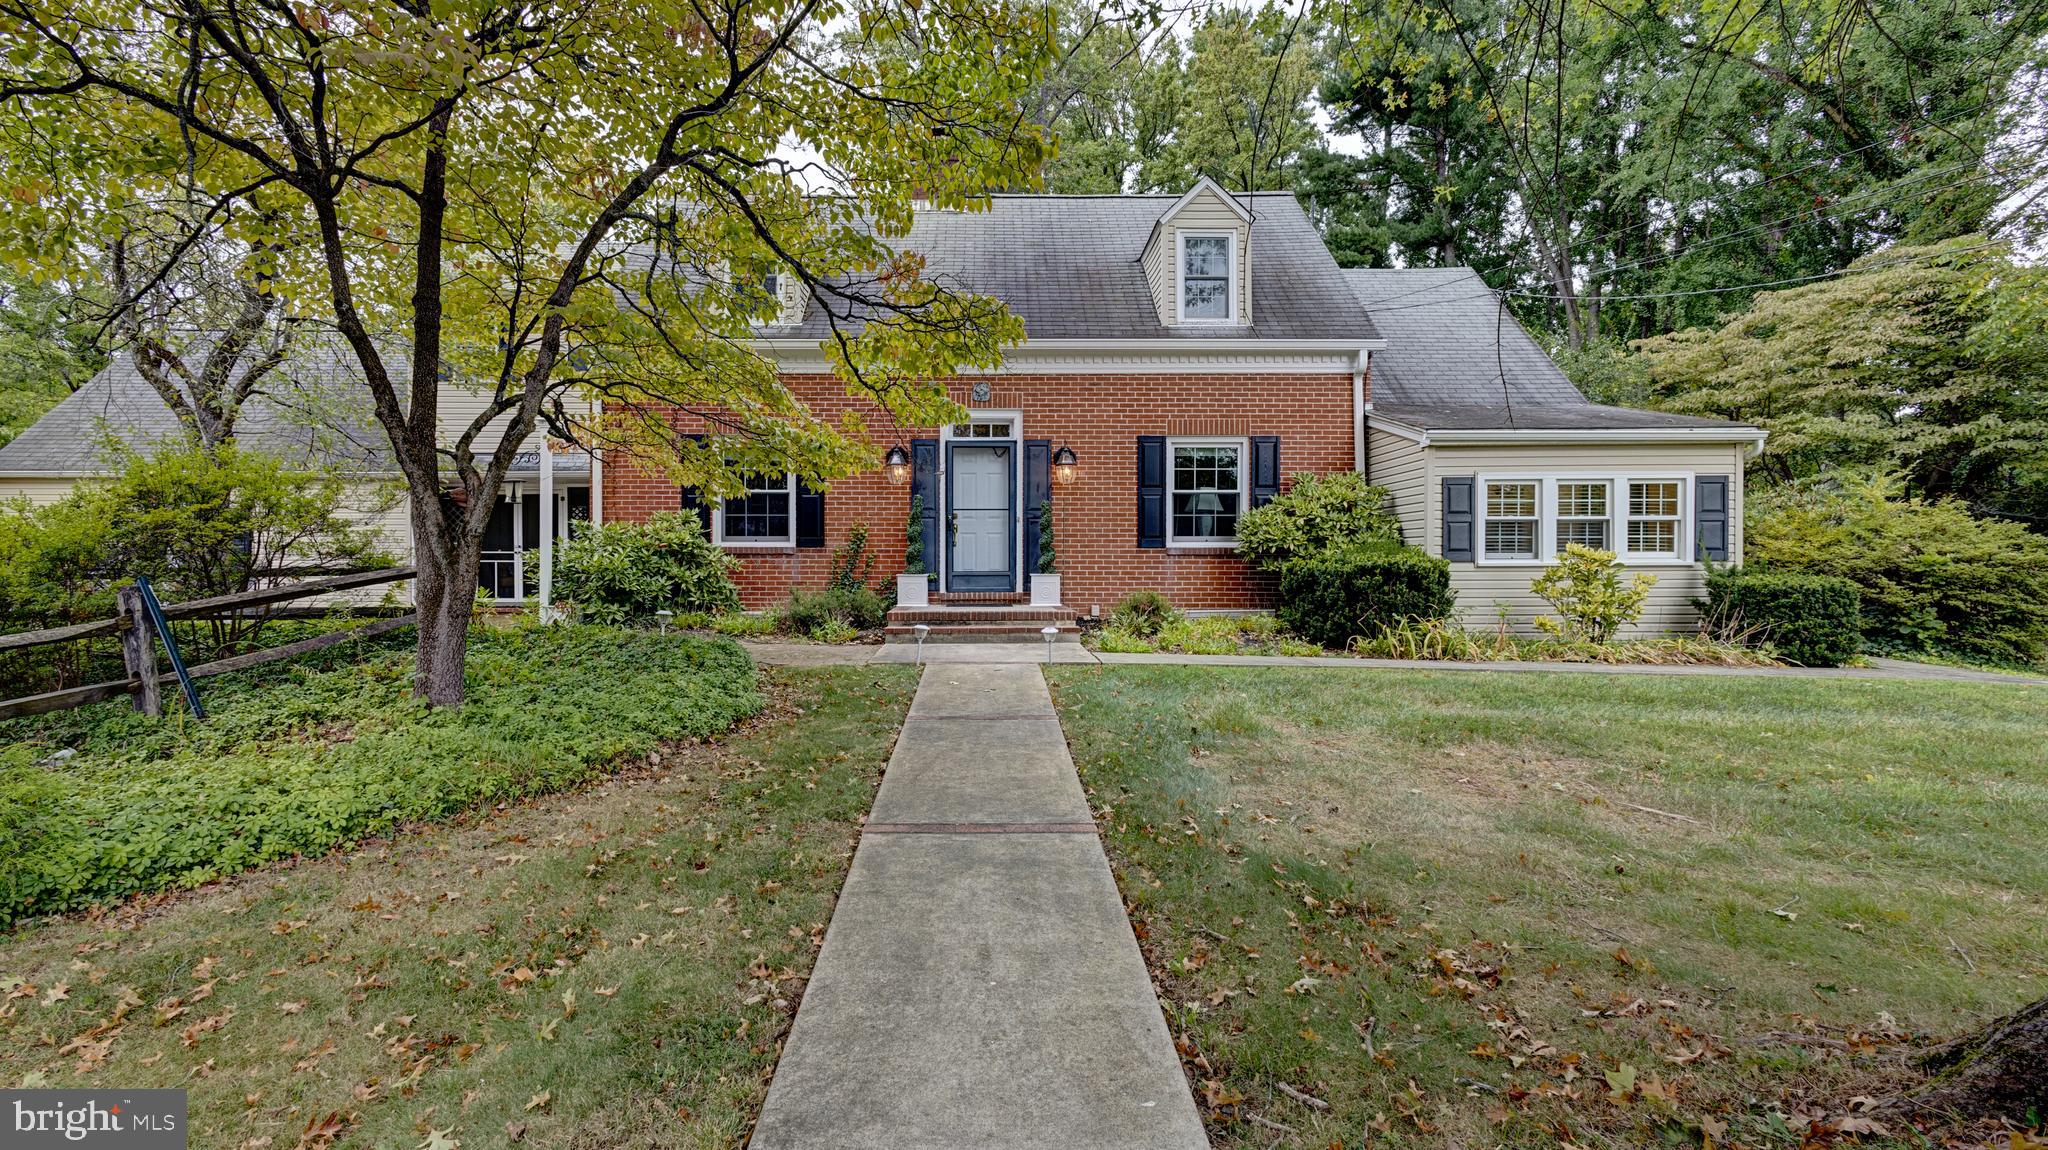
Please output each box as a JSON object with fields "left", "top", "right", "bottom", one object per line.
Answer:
{"left": 750, "top": 662, "right": 1208, "bottom": 1150}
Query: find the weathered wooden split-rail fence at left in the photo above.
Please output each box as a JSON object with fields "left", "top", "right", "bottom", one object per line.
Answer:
{"left": 0, "top": 567, "right": 420, "bottom": 718}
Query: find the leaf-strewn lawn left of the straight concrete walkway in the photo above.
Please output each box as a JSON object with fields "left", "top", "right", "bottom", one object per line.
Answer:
{"left": 0, "top": 667, "right": 915, "bottom": 1148}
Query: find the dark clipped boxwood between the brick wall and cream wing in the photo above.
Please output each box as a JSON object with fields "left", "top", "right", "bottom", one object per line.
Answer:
{"left": 1278, "top": 542, "right": 1456, "bottom": 649}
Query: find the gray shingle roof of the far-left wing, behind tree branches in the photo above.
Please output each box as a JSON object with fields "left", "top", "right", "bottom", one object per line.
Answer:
{"left": 0, "top": 344, "right": 408, "bottom": 477}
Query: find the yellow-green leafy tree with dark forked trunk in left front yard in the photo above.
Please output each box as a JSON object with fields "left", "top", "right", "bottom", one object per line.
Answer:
{"left": 0, "top": 0, "right": 1053, "bottom": 704}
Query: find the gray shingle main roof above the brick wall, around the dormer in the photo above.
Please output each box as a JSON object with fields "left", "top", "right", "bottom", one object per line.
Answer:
{"left": 768, "top": 192, "right": 1374, "bottom": 342}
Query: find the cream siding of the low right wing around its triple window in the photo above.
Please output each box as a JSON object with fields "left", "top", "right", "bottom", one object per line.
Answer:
{"left": 1425, "top": 432, "right": 1749, "bottom": 634}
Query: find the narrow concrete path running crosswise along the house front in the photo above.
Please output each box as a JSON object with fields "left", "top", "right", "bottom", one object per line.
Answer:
{"left": 745, "top": 643, "right": 2048, "bottom": 688}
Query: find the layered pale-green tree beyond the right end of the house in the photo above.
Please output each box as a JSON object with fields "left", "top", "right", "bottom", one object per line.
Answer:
{"left": 1636, "top": 237, "right": 2048, "bottom": 518}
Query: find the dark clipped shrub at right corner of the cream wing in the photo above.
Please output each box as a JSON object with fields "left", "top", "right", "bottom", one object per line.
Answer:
{"left": 1700, "top": 567, "right": 1864, "bottom": 667}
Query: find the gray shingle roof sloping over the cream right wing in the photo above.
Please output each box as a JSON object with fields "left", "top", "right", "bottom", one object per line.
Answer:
{"left": 1343, "top": 268, "right": 1749, "bottom": 432}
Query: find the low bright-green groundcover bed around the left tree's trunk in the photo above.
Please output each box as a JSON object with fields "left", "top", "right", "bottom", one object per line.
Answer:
{"left": 0, "top": 626, "right": 762, "bottom": 923}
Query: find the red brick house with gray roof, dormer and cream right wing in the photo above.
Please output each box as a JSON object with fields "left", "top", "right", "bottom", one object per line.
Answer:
{"left": 598, "top": 180, "right": 1761, "bottom": 628}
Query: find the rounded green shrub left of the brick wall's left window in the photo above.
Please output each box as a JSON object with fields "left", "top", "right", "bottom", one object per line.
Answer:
{"left": 555, "top": 512, "right": 739, "bottom": 624}
